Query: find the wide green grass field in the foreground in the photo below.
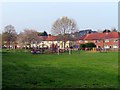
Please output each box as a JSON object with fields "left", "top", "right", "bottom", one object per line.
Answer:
{"left": 2, "top": 52, "right": 118, "bottom": 88}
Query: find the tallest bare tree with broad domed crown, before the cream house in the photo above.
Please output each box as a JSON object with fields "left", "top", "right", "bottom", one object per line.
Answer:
{"left": 51, "top": 17, "right": 78, "bottom": 48}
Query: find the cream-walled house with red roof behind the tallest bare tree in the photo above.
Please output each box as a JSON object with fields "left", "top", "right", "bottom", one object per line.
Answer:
{"left": 38, "top": 35, "right": 75, "bottom": 49}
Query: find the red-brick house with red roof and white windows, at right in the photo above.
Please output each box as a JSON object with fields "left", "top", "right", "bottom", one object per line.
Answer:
{"left": 76, "top": 32, "right": 120, "bottom": 49}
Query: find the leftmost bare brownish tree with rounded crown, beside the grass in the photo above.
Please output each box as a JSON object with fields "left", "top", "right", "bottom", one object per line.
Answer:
{"left": 2, "top": 25, "right": 17, "bottom": 49}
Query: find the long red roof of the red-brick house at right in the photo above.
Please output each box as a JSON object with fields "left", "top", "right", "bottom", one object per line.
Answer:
{"left": 80, "top": 32, "right": 119, "bottom": 40}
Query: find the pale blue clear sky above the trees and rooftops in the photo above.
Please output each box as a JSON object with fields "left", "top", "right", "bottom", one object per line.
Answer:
{"left": 0, "top": 1, "right": 118, "bottom": 33}
